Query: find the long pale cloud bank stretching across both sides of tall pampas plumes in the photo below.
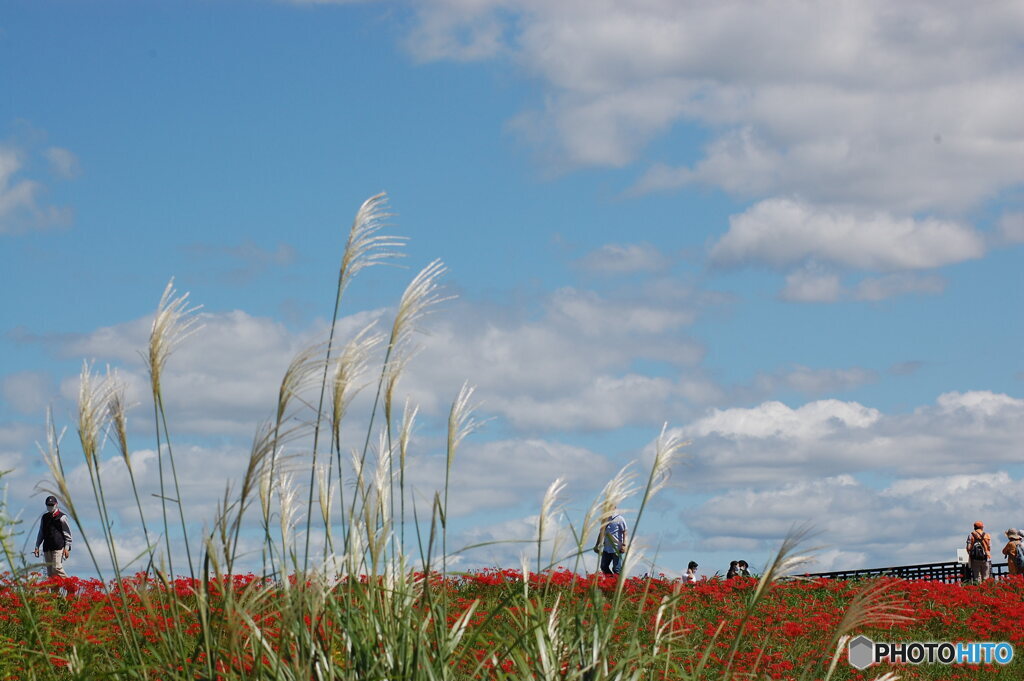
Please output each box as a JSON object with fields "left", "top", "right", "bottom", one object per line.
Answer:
{"left": 29, "top": 268, "right": 725, "bottom": 434}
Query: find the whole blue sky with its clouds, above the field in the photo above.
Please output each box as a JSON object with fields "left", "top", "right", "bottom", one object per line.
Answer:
{"left": 0, "top": 0, "right": 1024, "bottom": 573}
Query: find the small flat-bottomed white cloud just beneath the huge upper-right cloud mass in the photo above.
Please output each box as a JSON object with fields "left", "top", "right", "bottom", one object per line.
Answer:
{"left": 711, "top": 199, "right": 985, "bottom": 270}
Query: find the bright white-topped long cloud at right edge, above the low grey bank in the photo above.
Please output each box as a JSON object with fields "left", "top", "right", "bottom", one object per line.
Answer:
{"left": 681, "top": 391, "right": 1024, "bottom": 486}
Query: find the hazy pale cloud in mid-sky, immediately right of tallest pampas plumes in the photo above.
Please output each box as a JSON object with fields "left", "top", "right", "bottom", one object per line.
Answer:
{"left": 402, "top": 288, "right": 722, "bottom": 431}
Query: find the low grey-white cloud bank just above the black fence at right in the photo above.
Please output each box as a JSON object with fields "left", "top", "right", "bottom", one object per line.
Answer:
{"left": 686, "top": 471, "right": 1024, "bottom": 571}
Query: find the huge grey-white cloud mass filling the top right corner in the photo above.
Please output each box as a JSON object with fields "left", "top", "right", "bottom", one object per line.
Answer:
{"left": 410, "top": 0, "right": 1024, "bottom": 212}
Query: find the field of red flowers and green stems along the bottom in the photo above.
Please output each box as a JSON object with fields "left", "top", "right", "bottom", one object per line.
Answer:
{"left": 0, "top": 570, "right": 1024, "bottom": 680}
